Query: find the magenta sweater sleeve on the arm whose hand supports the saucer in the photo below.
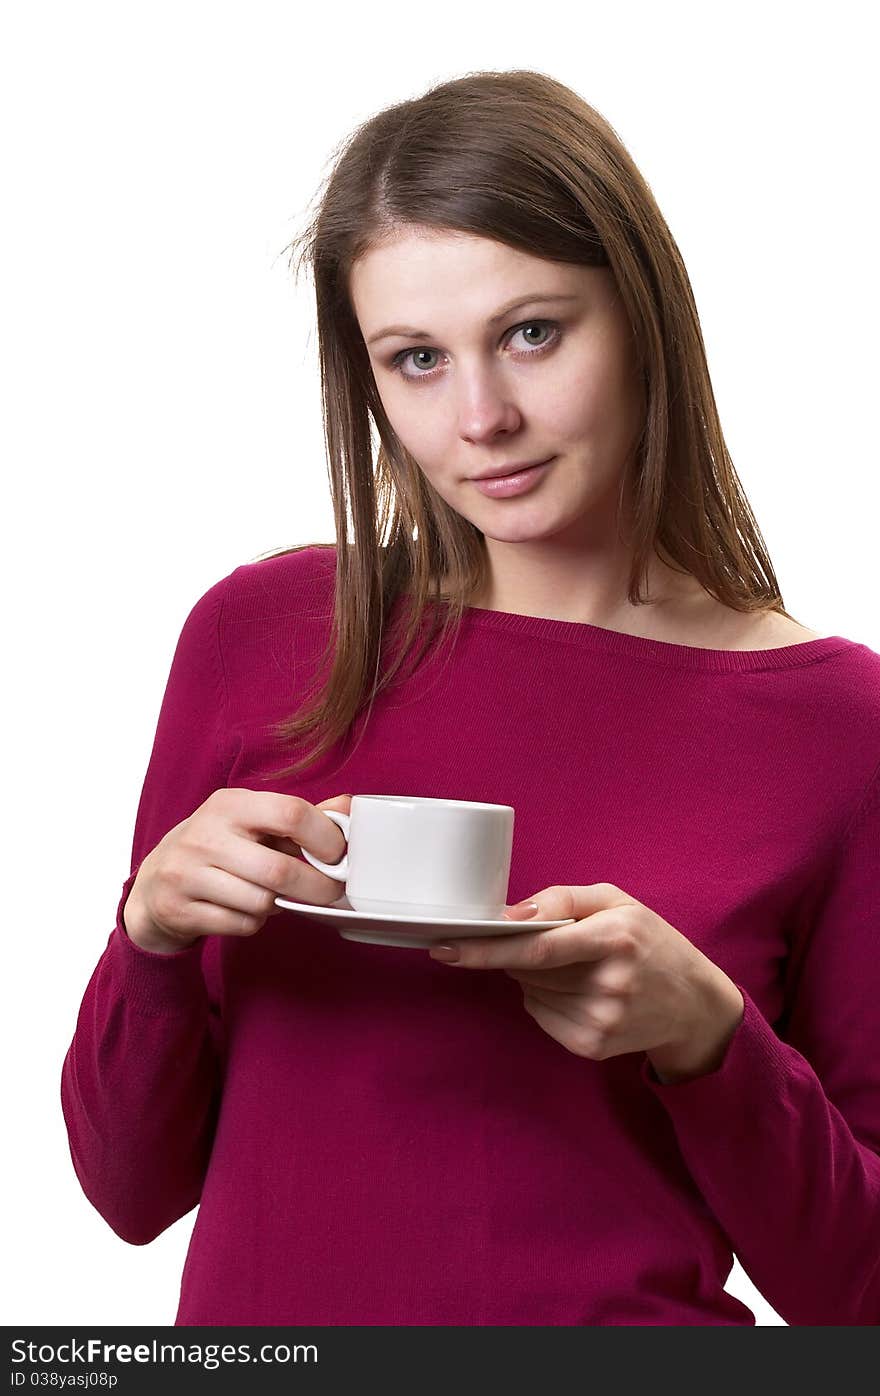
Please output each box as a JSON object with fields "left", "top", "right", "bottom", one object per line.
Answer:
{"left": 641, "top": 772, "right": 880, "bottom": 1326}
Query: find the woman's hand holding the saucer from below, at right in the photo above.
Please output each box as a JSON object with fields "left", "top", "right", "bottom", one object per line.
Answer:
{"left": 430, "top": 882, "right": 745, "bottom": 1085}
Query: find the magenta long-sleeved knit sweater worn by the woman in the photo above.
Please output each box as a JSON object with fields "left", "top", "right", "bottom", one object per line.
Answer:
{"left": 61, "top": 549, "right": 880, "bottom": 1325}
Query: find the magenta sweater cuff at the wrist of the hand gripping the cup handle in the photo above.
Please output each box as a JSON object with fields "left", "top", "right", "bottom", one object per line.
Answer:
{"left": 110, "top": 868, "right": 208, "bottom": 1018}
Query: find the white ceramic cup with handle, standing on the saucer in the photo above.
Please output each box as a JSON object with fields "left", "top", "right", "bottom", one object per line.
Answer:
{"left": 302, "top": 794, "right": 514, "bottom": 920}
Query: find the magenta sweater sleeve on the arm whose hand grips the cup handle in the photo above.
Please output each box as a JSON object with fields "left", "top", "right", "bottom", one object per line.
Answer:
{"left": 60, "top": 578, "right": 236, "bottom": 1245}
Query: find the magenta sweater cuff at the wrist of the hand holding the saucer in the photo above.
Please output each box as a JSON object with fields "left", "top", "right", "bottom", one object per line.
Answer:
{"left": 640, "top": 981, "right": 791, "bottom": 1105}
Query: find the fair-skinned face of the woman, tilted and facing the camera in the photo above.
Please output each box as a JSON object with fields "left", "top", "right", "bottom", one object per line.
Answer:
{"left": 351, "top": 229, "right": 644, "bottom": 543}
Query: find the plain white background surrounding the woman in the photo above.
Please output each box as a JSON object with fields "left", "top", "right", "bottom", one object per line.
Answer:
{"left": 0, "top": 0, "right": 880, "bottom": 1325}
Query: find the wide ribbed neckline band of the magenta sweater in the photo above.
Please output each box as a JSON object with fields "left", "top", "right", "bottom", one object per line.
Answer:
{"left": 452, "top": 606, "right": 856, "bottom": 673}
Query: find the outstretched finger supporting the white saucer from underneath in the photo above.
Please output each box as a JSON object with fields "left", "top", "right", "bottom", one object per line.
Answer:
{"left": 432, "top": 910, "right": 620, "bottom": 970}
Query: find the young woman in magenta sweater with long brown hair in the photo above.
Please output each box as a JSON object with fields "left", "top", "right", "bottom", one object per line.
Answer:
{"left": 61, "top": 71, "right": 880, "bottom": 1325}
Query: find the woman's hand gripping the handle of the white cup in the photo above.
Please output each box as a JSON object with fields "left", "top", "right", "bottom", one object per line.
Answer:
{"left": 123, "top": 789, "right": 352, "bottom": 955}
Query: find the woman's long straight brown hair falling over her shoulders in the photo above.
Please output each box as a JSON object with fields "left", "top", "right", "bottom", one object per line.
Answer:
{"left": 252, "top": 70, "right": 788, "bottom": 776}
